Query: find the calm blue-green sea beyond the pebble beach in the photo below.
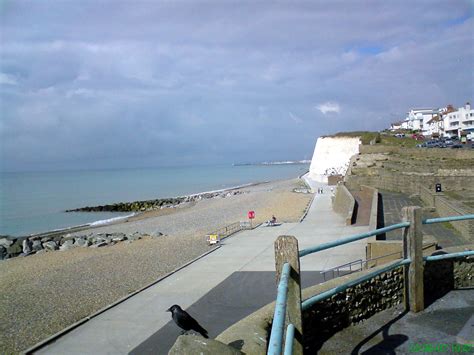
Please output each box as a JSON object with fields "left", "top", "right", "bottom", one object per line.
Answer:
{"left": 0, "top": 164, "right": 309, "bottom": 236}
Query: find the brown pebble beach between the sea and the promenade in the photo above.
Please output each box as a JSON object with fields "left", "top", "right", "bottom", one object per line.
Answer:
{"left": 0, "top": 179, "right": 312, "bottom": 353}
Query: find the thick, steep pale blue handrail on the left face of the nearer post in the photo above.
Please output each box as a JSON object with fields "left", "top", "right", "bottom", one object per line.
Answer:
{"left": 267, "top": 263, "right": 290, "bottom": 355}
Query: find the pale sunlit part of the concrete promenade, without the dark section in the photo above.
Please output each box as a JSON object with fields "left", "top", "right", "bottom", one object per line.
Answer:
{"left": 36, "top": 182, "right": 368, "bottom": 354}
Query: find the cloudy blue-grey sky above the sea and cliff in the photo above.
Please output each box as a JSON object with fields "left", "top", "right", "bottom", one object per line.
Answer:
{"left": 0, "top": 0, "right": 474, "bottom": 171}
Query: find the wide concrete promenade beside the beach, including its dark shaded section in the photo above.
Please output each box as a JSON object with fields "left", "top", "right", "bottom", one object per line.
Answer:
{"left": 36, "top": 185, "right": 369, "bottom": 354}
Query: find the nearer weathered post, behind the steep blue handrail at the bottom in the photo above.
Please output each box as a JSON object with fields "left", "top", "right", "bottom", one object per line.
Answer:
{"left": 275, "top": 235, "right": 303, "bottom": 355}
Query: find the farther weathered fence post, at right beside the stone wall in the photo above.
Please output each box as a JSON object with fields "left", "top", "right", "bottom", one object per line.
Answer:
{"left": 402, "top": 206, "right": 425, "bottom": 313}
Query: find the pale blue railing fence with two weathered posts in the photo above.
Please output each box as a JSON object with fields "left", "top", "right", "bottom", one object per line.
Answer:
{"left": 267, "top": 207, "right": 474, "bottom": 355}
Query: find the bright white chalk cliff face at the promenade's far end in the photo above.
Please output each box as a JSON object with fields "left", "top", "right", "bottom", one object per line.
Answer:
{"left": 307, "top": 137, "right": 360, "bottom": 183}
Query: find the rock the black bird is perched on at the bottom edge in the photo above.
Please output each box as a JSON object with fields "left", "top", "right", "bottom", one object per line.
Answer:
{"left": 168, "top": 335, "right": 243, "bottom": 355}
